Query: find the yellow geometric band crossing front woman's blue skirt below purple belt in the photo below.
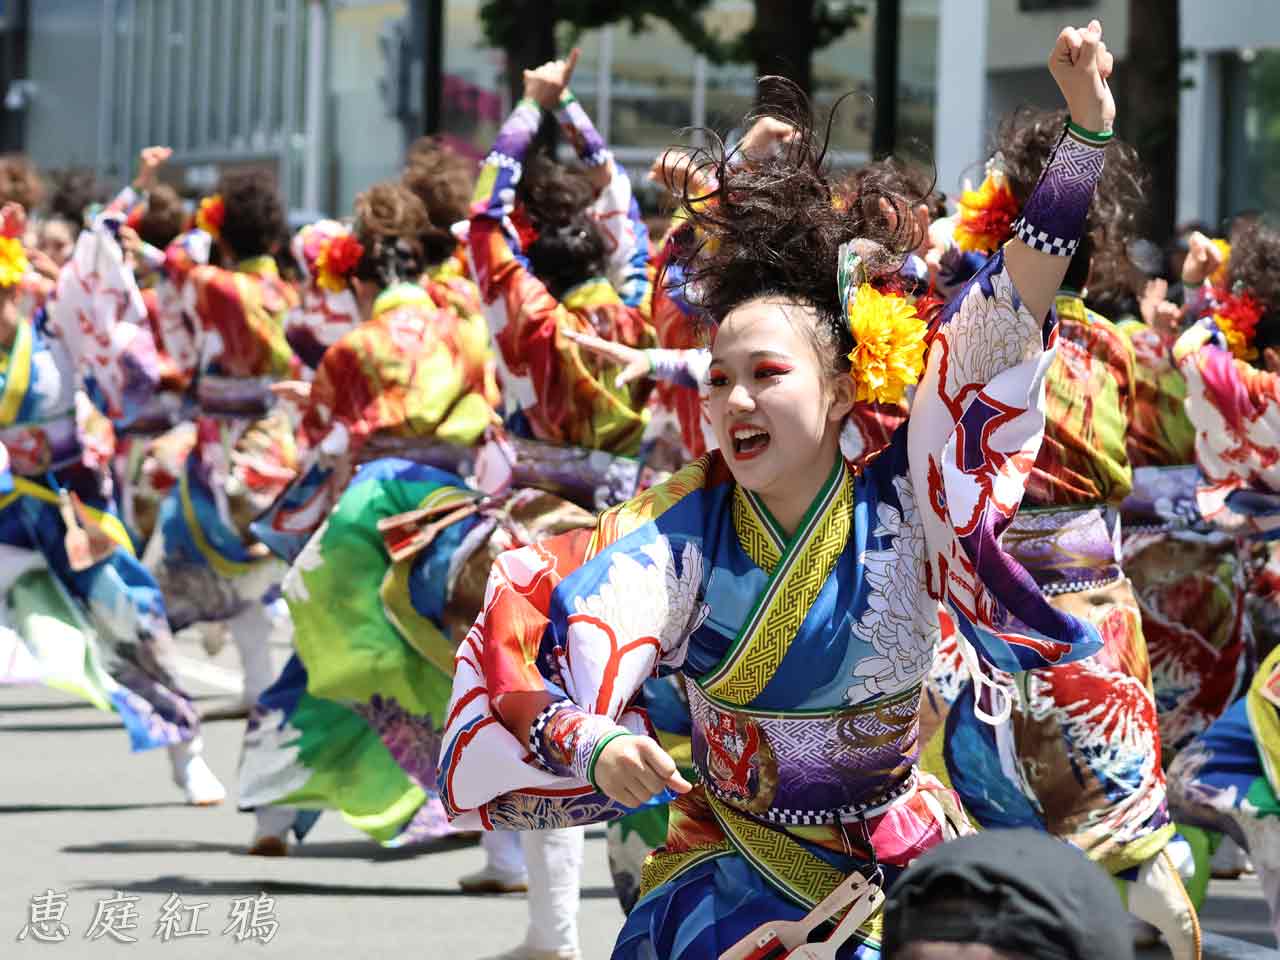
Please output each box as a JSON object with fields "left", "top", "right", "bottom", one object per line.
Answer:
{"left": 707, "top": 794, "right": 884, "bottom": 947}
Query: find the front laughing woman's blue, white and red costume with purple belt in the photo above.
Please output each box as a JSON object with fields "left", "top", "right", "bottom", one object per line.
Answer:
{"left": 439, "top": 244, "right": 1098, "bottom": 957}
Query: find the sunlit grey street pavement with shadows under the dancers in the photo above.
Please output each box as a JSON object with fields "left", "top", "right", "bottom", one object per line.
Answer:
{"left": 0, "top": 640, "right": 1280, "bottom": 960}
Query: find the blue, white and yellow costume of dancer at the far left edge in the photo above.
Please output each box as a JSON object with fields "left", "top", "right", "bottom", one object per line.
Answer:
{"left": 0, "top": 220, "right": 200, "bottom": 750}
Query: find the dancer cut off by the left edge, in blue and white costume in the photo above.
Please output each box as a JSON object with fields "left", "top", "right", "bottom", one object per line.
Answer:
{"left": 0, "top": 205, "right": 225, "bottom": 805}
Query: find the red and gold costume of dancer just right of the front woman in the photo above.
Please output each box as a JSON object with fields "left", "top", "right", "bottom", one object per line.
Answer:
{"left": 927, "top": 293, "right": 1198, "bottom": 956}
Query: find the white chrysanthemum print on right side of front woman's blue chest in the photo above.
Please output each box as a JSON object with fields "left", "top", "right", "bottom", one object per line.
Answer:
{"left": 845, "top": 476, "right": 938, "bottom": 703}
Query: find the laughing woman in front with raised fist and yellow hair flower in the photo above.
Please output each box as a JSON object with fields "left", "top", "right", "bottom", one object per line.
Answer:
{"left": 439, "top": 23, "right": 1115, "bottom": 957}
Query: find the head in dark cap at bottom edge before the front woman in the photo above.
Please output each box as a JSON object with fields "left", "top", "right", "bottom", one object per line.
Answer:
{"left": 882, "top": 829, "right": 1133, "bottom": 960}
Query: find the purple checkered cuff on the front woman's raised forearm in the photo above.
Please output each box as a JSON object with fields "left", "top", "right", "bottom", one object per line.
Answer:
{"left": 1014, "top": 134, "right": 1106, "bottom": 257}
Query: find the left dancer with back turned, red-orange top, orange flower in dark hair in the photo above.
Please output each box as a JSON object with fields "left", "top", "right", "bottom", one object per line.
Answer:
{"left": 145, "top": 172, "right": 297, "bottom": 703}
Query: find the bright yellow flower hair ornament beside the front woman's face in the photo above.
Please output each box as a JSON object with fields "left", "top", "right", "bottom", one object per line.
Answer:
{"left": 837, "top": 242, "right": 928, "bottom": 403}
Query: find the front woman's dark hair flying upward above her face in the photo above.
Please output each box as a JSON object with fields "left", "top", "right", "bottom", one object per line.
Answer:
{"left": 667, "top": 77, "right": 933, "bottom": 372}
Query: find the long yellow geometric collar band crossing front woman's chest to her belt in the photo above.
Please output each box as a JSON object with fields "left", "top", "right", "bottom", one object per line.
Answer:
{"left": 699, "top": 458, "right": 854, "bottom": 707}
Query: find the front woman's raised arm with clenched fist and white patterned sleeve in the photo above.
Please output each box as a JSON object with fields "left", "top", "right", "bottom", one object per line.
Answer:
{"left": 908, "top": 22, "right": 1115, "bottom": 686}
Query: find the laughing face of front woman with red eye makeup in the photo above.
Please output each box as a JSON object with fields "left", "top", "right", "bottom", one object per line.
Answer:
{"left": 708, "top": 297, "right": 852, "bottom": 525}
